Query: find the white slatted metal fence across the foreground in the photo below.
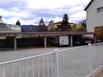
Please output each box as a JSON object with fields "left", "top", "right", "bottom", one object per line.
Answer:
{"left": 0, "top": 43, "right": 103, "bottom": 77}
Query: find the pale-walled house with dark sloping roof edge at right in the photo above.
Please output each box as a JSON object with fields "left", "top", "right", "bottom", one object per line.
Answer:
{"left": 84, "top": 0, "right": 103, "bottom": 32}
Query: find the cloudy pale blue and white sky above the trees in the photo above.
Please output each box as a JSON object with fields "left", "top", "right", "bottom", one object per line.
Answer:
{"left": 0, "top": 0, "right": 90, "bottom": 24}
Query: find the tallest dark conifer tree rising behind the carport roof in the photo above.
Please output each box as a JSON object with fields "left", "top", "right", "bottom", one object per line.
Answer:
{"left": 60, "top": 14, "right": 70, "bottom": 31}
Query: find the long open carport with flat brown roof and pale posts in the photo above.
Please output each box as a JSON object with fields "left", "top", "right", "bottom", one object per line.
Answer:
{"left": 0, "top": 32, "right": 96, "bottom": 50}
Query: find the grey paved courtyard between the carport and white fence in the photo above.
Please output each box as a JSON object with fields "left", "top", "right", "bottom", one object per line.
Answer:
{"left": 0, "top": 47, "right": 73, "bottom": 63}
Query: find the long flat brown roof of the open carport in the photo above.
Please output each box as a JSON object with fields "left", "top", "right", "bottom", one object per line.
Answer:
{"left": 0, "top": 32, "right": 94, "bottom": 37}
